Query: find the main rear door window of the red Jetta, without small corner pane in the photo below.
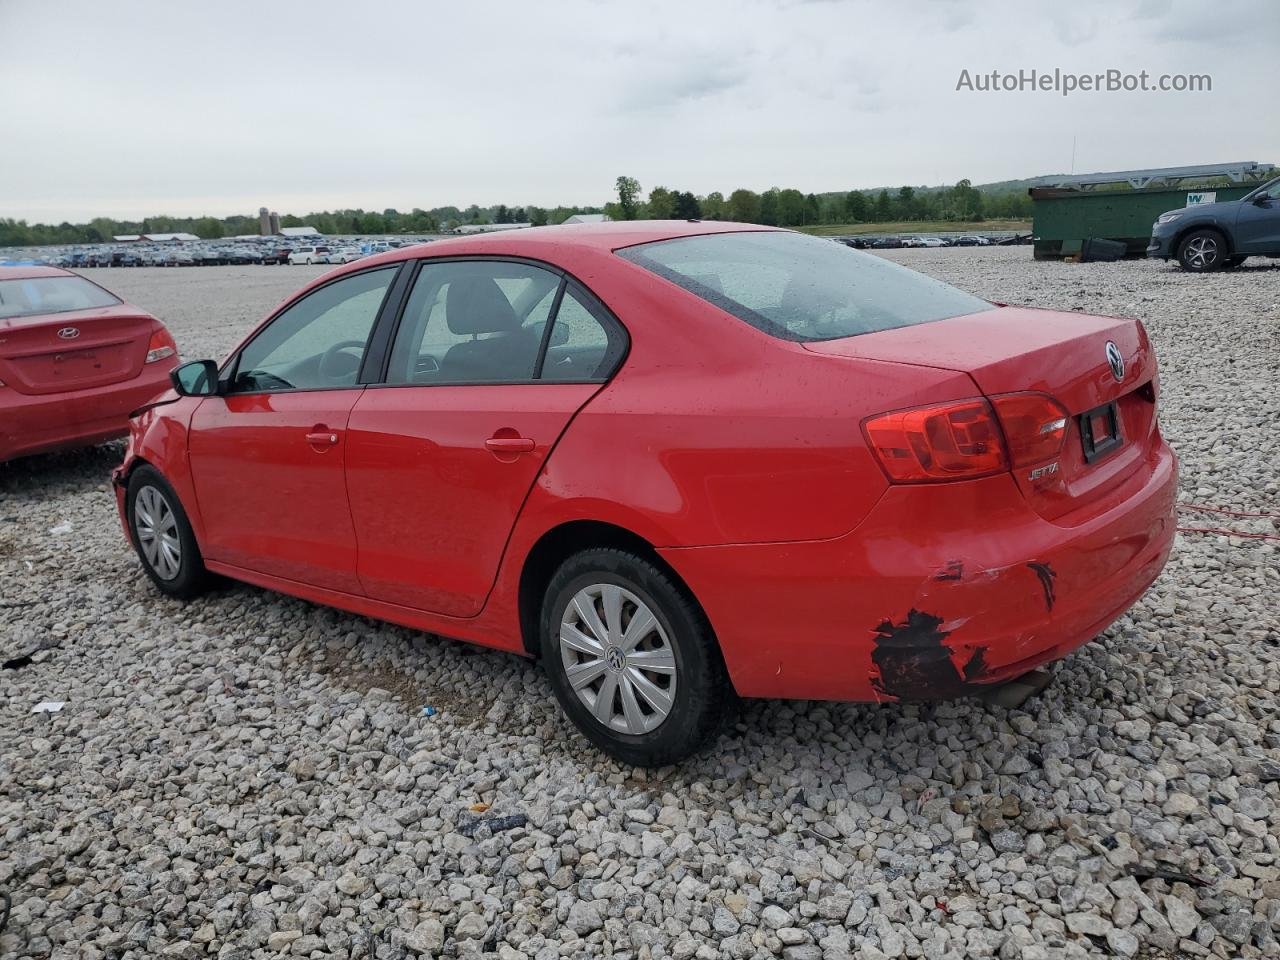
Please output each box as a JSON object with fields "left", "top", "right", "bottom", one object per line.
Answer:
{"left": 387, "top": 260, "right": 561, "bottom": 385}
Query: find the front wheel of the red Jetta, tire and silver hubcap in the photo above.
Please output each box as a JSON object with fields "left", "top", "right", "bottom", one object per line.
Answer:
{"left": 125, "top": 466, "right": 209, "bottom": 600}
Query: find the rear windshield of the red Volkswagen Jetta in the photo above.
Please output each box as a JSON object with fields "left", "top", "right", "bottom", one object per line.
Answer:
{"left": 618, "top": 232, "right": 991, "bottom": 340}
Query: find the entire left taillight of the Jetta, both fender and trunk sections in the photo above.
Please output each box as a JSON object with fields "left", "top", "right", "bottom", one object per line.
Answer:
{"left": 863, "top": 393, "right": 1068, "bottom": 484}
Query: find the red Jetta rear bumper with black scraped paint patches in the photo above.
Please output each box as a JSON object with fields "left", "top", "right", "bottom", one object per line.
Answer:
{"left": 660, "top": 440, "right": 1178, "bottom": 700}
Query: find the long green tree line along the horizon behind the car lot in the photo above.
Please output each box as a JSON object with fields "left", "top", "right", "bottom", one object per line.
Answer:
{"left": 0, "top": 177, "right": 1030, "bottom": 247}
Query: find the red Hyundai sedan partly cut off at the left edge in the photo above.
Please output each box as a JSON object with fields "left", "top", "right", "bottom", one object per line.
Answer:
{"left": 0, "top": 266, "right": 178, "bottom": 462}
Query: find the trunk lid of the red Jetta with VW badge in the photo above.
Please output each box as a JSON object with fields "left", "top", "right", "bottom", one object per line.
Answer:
{"left": 805, "top": 307, "right": 1158, "bottom": 520}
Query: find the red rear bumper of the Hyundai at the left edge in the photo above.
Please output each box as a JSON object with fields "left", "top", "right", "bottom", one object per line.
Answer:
{"left": 0, "top": 357, "right": 178, "bottom": 462}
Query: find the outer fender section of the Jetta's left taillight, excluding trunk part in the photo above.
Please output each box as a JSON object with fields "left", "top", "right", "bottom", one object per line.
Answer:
{"left": 863, "top": 399, "right": 1009, "bottom": 484}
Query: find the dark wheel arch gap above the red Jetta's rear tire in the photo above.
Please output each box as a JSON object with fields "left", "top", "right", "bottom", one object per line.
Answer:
{"left": 517, "top": 520, "right": 709, "bottom": 658}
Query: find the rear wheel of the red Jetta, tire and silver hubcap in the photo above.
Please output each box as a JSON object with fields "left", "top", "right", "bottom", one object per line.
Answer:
{"left": 540, "top": 548, "right": 736, "bottom": 767}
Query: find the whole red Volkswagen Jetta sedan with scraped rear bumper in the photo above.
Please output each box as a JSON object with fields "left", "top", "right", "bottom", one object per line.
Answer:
{"left": 115, "top": 221, "right": 1176, "bottom": 764}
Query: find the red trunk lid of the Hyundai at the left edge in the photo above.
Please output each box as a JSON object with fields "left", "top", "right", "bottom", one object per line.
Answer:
{"left": 0, "top": 305, "right": 156, "bottom": 396}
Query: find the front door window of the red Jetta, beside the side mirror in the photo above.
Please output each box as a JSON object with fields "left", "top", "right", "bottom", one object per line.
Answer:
{"left": 230, "top": 266, "right": 399, "bottom": 393}
